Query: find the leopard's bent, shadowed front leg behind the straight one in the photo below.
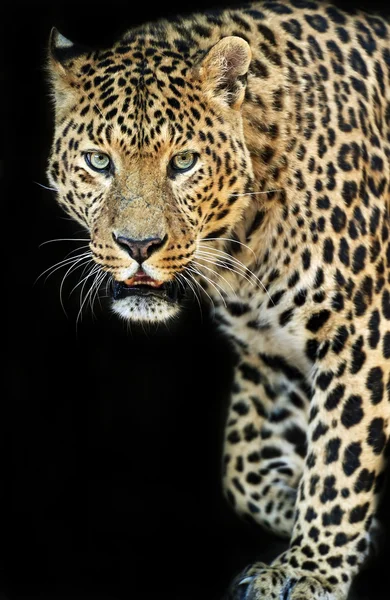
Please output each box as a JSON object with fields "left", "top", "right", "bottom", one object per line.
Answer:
{"left": 224, "top": 356, "right": 309, "bottom": 537}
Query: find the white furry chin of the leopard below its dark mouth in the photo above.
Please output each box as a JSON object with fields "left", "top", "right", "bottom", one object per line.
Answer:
{"left": 112, "top": 296, "right": 179, "bottom": 323}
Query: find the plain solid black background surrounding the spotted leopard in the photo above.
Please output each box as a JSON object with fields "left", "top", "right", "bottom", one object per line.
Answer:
{"left": 0, "top": 0, "right": 390, "bottom": 600}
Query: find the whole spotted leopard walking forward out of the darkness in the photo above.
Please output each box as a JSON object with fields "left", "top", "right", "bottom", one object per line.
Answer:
{"left": 45, "top": 0, "right": 390, "bottom": 600}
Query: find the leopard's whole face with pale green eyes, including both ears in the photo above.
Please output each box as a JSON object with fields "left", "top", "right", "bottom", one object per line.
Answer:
{"left": 48, "top": 32, "right": 253, "bottom": 321}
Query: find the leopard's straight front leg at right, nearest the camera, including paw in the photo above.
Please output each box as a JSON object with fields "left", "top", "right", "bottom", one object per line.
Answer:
{"left": 230, "top": 322, "right": 390, "bottom": 600}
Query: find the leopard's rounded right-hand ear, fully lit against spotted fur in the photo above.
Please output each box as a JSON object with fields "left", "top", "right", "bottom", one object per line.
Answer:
{"left": 193, "top": 36, "right": 252, "bottom": 110}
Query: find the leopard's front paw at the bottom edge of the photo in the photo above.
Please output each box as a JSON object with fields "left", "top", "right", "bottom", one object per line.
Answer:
{"left": 227, "top": 563, "right": 346, "bottom": 600}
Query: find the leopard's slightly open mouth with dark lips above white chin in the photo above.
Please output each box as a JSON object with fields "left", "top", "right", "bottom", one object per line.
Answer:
{"left": 111, "top": 274, "right": 183, "bottom": 303}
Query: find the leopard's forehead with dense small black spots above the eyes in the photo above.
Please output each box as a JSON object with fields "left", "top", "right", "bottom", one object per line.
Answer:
{"left": 66, "top": 38, "right": 210, "bottom": 154}
